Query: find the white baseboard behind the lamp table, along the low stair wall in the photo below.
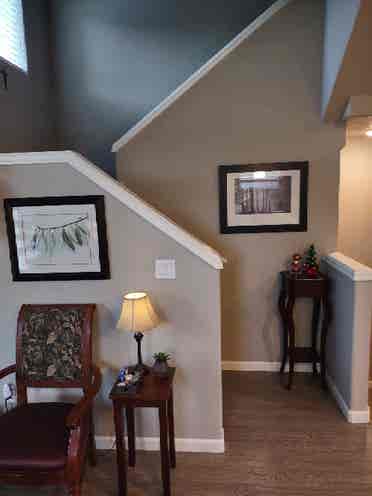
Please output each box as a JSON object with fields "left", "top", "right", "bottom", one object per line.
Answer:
{"left": 96, "top": 436, "right": 225, "bottom": 453}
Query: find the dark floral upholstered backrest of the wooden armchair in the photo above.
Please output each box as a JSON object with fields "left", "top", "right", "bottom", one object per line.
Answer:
{"left": 17, "top": 304, "right": 95, "bottom": 388}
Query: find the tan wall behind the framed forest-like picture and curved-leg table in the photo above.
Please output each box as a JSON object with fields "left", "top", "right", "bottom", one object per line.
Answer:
{"left": 117, "top": 0, "right": 344, "bottom": 361}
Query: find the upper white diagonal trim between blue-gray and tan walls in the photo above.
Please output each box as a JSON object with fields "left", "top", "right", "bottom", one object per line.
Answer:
{"left": 112, "top": 0, "right": 292, "bottom": 152}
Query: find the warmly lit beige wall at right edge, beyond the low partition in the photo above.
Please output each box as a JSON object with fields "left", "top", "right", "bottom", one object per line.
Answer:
{"left": 338, "top": 130, "right": 372, "bottom": 266}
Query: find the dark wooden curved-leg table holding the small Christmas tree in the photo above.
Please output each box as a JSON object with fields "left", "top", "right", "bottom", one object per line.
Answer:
{"left": 279, "top": 271, "right": 331, "bottom": 389}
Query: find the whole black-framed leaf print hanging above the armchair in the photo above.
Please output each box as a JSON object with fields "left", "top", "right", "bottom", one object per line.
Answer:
{"left": 4, "top": 196, "right": 110, "bottom": 281}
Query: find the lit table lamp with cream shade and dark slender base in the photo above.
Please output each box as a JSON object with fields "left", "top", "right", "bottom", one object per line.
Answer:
{"left": 116, "top": 293, "right": 160, "bottom": 373}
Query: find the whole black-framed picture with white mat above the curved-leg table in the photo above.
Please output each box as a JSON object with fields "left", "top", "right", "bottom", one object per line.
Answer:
{"left": 219, "top": 162, "right": 309, "bottom": 234}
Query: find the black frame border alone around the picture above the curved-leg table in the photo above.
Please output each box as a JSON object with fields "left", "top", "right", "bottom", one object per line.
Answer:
{"left": 218, "top": 162, "right": 309, "bottom": 234}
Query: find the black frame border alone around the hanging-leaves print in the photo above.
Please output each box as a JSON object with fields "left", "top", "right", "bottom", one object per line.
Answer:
{"left": 4, "top": 195, "right": 110, "bottom": 281}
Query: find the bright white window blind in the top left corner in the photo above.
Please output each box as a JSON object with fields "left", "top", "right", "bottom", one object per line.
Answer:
{"left": 0, "top": 0, "right": 27, "bottom": 72}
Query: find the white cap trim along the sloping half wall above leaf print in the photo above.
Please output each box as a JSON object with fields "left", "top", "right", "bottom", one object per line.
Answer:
{"left": 0, "top": 150, "right": 225, "bottom": 269}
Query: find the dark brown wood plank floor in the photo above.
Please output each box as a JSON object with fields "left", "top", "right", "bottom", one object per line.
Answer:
{"left": 0, "top": 372, "right": 372, "bottom": 496}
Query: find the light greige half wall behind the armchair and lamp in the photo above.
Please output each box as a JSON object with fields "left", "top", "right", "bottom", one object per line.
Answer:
{"left": 0, "top": 165, "right": 222, "bottom": 439}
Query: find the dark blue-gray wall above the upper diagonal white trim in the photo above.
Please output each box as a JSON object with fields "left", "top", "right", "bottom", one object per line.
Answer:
{"left": 50, "top": 0, "right": 274, "bottom": 174}
